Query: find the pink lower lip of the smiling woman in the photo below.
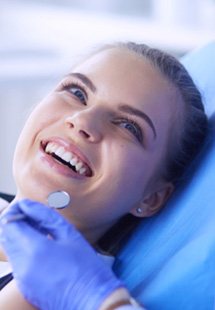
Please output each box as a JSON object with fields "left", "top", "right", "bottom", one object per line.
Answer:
{"left": 40, "top": 147, "right": 85, "bottom": 180}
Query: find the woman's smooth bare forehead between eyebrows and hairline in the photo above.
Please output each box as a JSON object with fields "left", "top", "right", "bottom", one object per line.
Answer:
{"left": 73, "top": 48, "right": 180, "bottom": 136}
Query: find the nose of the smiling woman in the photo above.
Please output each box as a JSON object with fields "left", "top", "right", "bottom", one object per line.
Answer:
{"left": 65, "top": 108, "right": 103, "bottom": 143}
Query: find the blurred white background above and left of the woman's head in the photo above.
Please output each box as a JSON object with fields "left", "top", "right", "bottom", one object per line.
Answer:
{"left": 0, "top": 0, "right": 215, "bottom": 193}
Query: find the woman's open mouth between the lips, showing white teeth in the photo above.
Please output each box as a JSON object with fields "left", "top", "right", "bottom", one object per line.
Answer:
{"left": 42, "top": 142, "right": 93, "bottom": 177}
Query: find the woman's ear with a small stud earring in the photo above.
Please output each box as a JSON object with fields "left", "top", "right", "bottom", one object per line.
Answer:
{"left": 130, "top": 182, "right": 174, "bottom": 217}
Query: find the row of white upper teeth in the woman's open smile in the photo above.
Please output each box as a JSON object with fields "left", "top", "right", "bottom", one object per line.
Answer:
{"left": 45, "top": 142, "right": 87, "bottom": 174}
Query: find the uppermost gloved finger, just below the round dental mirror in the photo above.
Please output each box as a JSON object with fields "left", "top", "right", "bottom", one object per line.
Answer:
{"left": 13, "top": 199, "right": 77, "bottom": 240}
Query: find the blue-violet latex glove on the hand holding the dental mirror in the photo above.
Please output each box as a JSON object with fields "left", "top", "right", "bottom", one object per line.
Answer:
{"left": 1, "top": 200, "right": 123, "bottom": 310}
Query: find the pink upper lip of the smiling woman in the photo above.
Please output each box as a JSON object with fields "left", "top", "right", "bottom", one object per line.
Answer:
{"left": 41, "top": 137, "right": 93, "bottom": 176}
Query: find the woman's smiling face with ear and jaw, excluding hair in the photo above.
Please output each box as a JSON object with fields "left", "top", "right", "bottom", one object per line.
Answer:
{"left": 14, "top": 49, "right": 179, "bottom": 241}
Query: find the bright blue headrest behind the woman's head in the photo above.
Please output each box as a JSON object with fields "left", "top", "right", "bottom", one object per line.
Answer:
{"left": 114, "top": 42, "right": 215, "bottom": 310}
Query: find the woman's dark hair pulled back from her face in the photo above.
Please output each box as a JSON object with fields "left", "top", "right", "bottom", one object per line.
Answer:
{"left": 97, "top": 42, "right": 208, "bottom": 252}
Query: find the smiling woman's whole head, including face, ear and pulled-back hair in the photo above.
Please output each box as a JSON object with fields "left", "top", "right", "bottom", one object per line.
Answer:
{"left": 0, "top": 43, "right": 207, "bottom": 309}
